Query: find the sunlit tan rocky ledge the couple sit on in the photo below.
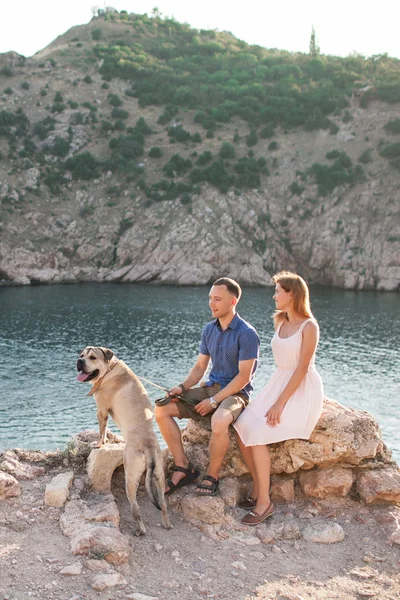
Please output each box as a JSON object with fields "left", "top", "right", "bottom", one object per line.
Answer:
{"left": 0, "top": 400, "right": 400, "bottom": 591}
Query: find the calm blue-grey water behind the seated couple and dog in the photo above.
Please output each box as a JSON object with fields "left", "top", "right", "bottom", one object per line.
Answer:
{"left": 0, "top": 284, "right": 400, "bottom": 461}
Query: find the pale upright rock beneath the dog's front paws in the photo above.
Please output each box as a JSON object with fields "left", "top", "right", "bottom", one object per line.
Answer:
{"left": 87, "top": 443, "right": 125, "bottom": 493}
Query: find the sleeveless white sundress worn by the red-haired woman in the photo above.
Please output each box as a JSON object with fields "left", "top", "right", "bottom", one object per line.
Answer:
{"left": 233, "top": 319, "right": 324, "bottom": 446}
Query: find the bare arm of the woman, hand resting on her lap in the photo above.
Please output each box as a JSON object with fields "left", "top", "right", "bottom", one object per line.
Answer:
{"left": 265, "top": 321, "right": 319, "bottom": 427}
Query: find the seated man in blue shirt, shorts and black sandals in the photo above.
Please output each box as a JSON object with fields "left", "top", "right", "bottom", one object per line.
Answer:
{"left": 155, "top": 277, "right": 260, "bottom": 496}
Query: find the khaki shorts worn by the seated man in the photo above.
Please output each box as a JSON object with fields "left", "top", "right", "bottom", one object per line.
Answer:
{"left": 176, "top": 383, "right": 248, "bottom": 423}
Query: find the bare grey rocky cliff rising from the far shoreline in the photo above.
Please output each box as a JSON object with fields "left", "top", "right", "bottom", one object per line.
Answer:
{"left": 0, "top": 45, "right": 400, "bottom": 290}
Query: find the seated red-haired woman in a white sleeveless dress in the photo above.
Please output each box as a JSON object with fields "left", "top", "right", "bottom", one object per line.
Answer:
{"left": 233, "top": 271, "right": 324, "bottom": 525}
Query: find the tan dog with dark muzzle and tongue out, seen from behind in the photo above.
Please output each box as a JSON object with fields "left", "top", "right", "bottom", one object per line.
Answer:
{"left": 76, "top": 346, "right": 171, "bottom": 536}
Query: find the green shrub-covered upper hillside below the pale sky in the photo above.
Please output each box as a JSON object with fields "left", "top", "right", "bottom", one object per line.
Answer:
{"left": 0, "top": 12, "right": 400, "bottom": 204}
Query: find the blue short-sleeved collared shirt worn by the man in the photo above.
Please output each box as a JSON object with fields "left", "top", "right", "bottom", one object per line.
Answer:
{"left": 200, "top": 314, "right": 260, "bottom": 398}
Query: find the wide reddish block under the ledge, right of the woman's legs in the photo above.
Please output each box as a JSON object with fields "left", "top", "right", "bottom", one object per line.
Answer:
{"left": 299, "top": 467, "right": 354, "bottom": 498}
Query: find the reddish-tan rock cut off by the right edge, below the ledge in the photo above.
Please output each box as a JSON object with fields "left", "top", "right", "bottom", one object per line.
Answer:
{"left": 356, "top": 467, "right": 400, "bottom": 504}
